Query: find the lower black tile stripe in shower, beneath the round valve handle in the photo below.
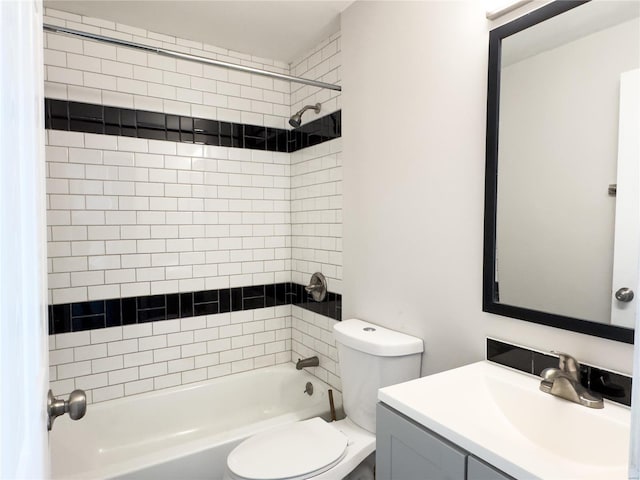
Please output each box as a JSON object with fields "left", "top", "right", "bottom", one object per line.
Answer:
{"left": 49, "top": 283, "right": 342, "bottom": 335}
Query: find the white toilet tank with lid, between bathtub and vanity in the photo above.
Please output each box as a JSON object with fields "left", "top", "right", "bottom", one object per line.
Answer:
{"left": 333, "top": 319, "right": 424, "bottom": 433}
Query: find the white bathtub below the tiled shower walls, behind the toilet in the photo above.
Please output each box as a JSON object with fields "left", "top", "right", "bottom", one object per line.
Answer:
{"left": 49, "top": 364, "right": 341, "bottom": 480}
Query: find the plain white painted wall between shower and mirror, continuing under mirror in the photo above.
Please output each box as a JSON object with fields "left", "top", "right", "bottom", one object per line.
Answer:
{"left": 342, "top": 1, "right": 633, "bottom": 375}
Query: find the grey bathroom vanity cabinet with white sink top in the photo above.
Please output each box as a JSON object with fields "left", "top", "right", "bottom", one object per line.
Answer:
{"left": 376, "top": 361, "right": 630, "bottom": 480}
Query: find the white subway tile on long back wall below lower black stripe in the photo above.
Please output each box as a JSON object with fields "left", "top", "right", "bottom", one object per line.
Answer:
{"left": 49, "top": 305, "right": 295, "bottom": 403}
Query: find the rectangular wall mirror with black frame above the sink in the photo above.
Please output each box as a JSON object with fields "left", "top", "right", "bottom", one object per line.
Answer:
{"left": 483, "top": 0, "right": 640, "bottom": 343}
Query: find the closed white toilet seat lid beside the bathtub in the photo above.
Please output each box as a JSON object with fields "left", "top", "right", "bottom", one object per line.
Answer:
{"left": 227, "top": 417, "right": 348, "bottom": 480}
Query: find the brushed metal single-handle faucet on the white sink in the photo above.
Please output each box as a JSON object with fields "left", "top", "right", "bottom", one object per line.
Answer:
{"left": 540, "top": 352, "right": 604, "bottom": 408}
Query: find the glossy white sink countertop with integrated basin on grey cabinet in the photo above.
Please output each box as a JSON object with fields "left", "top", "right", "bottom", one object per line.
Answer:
{"left": 378, "top": 362, "right": 631, "bottom": 480}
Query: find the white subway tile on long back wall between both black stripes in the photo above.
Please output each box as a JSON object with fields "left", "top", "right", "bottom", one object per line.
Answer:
{"left": 47, "top": 130, "right": 291, "bottom": 304}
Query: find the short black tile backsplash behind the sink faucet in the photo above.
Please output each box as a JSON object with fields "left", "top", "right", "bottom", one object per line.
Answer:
{"left": 487, "top": 338, "right": 632, "bottom": 406}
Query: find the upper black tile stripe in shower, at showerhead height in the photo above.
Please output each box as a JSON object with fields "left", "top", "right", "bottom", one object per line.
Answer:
{"left": 45, "top": 98, "right": 342, "bottom": 153}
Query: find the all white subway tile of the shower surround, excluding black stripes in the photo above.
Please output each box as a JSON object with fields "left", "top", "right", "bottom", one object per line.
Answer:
{"left": 44, "top": 9, "right": 342, "bottom": 402}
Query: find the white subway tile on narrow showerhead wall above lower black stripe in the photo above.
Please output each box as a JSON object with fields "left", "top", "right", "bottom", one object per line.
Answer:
{"left": 291, "top": 32, "right": 342, "bottom": 293}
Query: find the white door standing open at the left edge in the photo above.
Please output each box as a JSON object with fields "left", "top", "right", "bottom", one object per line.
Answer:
{"left": 0, "top": 0, "right": 49, "bottom": 479}
